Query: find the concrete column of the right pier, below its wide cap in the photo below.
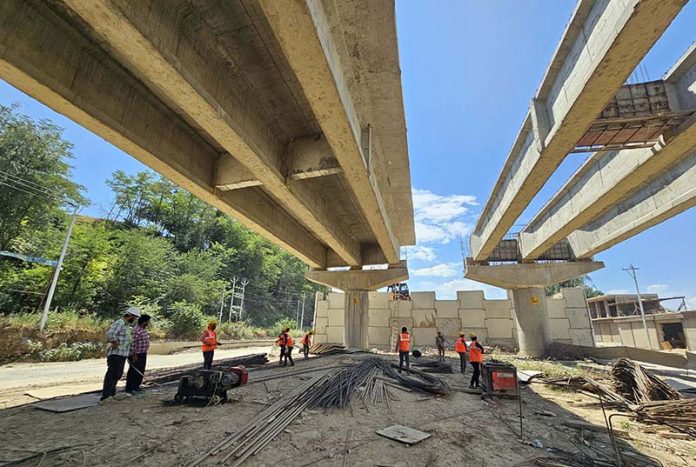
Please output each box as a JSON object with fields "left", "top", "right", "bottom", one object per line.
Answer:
{"left": 512, "top": 287, "right": 551, "bottom": 357}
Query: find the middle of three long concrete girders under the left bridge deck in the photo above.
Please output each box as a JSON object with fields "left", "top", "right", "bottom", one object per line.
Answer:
{"left": 63, "top": 0, "right": 361, "bottom": 265}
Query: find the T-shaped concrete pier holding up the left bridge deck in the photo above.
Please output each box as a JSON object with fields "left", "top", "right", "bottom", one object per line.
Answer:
{"left": 305, "top": 261, "right": 408, "bottom": 350}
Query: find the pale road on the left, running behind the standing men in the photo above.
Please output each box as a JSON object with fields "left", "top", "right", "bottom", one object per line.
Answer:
{"left": 0, "top": 346, "right": 269, "bottom": 408}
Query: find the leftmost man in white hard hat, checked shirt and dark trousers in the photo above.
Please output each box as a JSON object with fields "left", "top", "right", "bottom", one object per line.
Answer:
{"left": 100, "top": 307, "right": 140, "bottom": 400}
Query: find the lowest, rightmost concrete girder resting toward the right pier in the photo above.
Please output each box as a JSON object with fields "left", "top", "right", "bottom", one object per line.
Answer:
{"left": 568, "top": 151, "right": 696, "bottom": 258}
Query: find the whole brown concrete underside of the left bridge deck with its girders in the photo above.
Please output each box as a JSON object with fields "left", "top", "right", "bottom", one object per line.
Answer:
{"left": 0, "top": 0, "right": 415, "bottom": 268}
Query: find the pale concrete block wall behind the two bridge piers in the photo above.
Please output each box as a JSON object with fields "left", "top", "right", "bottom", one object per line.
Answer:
{"left": 314, "top": 289, "right": 593, "bottom": 349}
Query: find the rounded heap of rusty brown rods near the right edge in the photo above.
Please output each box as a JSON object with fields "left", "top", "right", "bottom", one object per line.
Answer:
{"left": 611, "top": 358, "right": 681, "bottom": 404}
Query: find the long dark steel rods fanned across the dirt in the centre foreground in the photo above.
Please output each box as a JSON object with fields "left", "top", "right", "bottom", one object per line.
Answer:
{"left": 191, "top": 357, "right": 450, "bottom": 466}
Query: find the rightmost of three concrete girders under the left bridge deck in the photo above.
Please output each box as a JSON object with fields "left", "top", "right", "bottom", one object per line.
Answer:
{"left": 259, "top": 0, "right": 400, "bottom": 263}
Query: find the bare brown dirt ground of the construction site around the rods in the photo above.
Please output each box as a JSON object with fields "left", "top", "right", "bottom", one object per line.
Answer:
{"left": 0, "top": 353, "right": 696, "bottom": 466}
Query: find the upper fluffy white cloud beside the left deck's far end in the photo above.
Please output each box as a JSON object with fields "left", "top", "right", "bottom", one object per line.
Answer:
{"left": 413, "top": 189, "right": 478, "bottom": 244}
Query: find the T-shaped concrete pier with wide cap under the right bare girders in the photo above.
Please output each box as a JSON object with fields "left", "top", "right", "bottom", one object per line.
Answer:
{"left": 465, "top": 261, "right": 604, "bottom": 357}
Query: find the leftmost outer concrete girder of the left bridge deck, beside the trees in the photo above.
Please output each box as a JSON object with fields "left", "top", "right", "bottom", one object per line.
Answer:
{"left": 0, "top": 0, "right": 327, "bottom": 267}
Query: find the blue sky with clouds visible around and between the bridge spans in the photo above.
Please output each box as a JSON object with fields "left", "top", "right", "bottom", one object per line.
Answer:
{"left": 0, "top": 0, "right": 696, "bottom": 308}
